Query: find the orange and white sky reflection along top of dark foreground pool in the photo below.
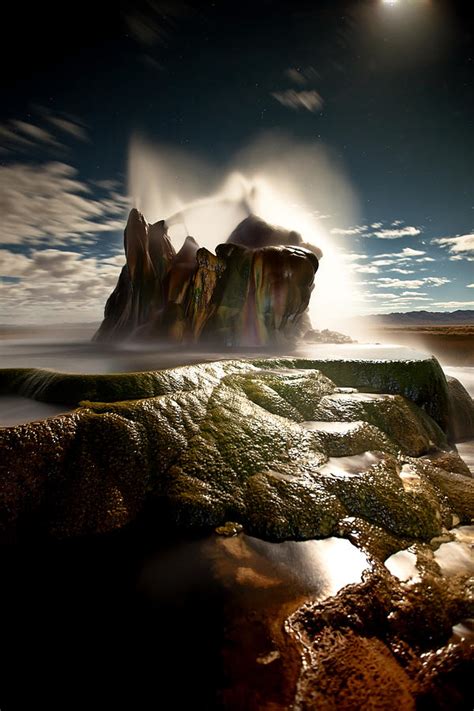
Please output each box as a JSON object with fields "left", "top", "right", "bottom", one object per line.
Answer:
{"left": 139, "top": 534, "right": 369, "bottom": 605}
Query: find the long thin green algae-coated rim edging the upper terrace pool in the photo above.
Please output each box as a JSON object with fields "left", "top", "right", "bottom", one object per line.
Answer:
{"left": 0, "top": 358, "right": 450, "bottom": 432}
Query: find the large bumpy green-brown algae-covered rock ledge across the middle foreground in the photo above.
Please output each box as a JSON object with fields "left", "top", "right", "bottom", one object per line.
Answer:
{"left": 0, "top": 360, "right": 470, "bottom": 541}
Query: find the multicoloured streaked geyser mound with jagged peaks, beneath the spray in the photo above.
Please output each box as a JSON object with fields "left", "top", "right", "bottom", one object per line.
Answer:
{"left": 95, "top": 208, "right": 322, "bottom": 347}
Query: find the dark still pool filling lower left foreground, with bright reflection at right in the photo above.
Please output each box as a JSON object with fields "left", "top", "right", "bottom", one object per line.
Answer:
{"left": 0, "top": 526, "right": 368, "bottom": 711}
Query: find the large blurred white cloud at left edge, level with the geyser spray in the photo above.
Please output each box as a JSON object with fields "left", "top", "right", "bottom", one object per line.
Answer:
{"left": 0, "top": 162, "right": 127, "bottom": 245}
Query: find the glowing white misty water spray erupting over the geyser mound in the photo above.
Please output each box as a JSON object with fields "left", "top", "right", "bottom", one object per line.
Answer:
{"left": 129, "top": 133, "right": 358, "bottom": 329}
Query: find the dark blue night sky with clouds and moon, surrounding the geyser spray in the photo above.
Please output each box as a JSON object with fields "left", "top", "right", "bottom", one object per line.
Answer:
{"left": 0, "top": 0, "right": 474, "bottom": 323}
